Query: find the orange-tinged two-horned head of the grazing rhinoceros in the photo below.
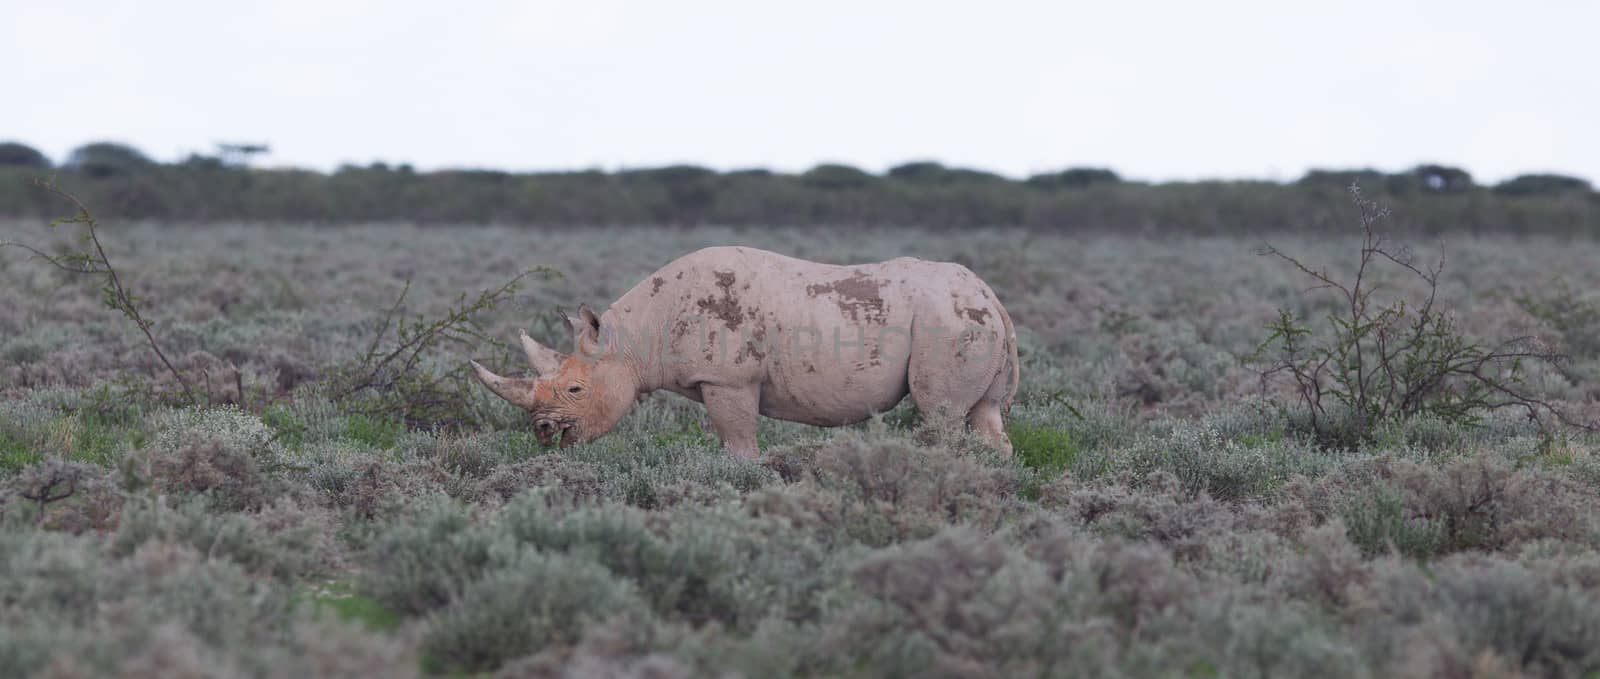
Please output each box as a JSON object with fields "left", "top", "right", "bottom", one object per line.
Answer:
{"left": 472, "top": 306, "right": 638, "bottom": 447}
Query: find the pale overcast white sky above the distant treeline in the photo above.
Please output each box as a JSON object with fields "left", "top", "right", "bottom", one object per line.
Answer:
{"left": 0, "top": 0, "right": 1600, "bottom": 181}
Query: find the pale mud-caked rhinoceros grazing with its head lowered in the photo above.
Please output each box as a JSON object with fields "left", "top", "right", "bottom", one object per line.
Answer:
{"left": 472, "top": 247, "right": 1019, "bottom": 458}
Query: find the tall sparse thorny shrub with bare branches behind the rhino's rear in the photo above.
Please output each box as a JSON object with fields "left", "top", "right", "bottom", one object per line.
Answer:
{"left": 1253, "top": 185, "right": 1565, "bottom": 448}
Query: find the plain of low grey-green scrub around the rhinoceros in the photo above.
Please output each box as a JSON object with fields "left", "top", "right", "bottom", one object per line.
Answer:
{"left": 0, "top": 223, "right": 1600, "bottom": 677}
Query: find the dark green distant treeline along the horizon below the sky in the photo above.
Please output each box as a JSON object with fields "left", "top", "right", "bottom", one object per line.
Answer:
{"left": 0, "top": 143, "right": 1600, "bottom": 235}
